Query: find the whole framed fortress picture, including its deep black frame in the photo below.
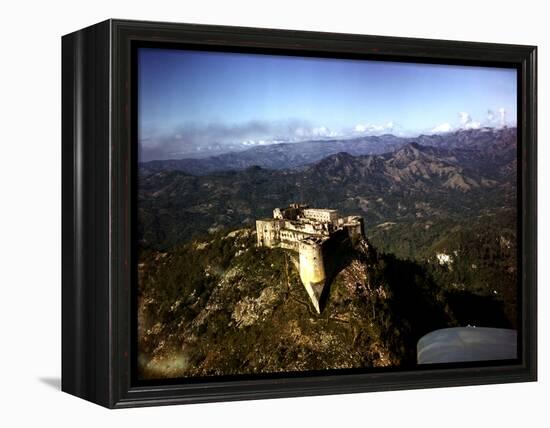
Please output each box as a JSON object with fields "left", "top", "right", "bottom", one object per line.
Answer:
{"left": 62, "top": 20, "right": 537, "bottom": 408}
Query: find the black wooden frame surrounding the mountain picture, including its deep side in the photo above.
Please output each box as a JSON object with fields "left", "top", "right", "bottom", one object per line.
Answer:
{"left": 62, "top": 20, "right": 537, "bottom": 408}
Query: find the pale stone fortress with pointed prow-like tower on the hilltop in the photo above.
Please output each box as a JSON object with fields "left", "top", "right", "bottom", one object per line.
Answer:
{"left": 256, "top": 204, "right": 364, "bottom": 313}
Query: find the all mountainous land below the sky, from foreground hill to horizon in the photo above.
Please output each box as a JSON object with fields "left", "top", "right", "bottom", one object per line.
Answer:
{"left": 138, "top": 124, "right": 518, "bottom": 379}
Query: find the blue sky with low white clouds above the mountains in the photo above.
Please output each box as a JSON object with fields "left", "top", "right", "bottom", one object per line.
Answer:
{"left": 138, "top": 48, "right": 516, "bottom": 160}
